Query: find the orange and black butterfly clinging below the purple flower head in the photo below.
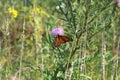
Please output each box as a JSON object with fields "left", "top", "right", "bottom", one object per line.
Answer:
{"left": 53, "top": 35, "right": 73, "bottom": 48}
